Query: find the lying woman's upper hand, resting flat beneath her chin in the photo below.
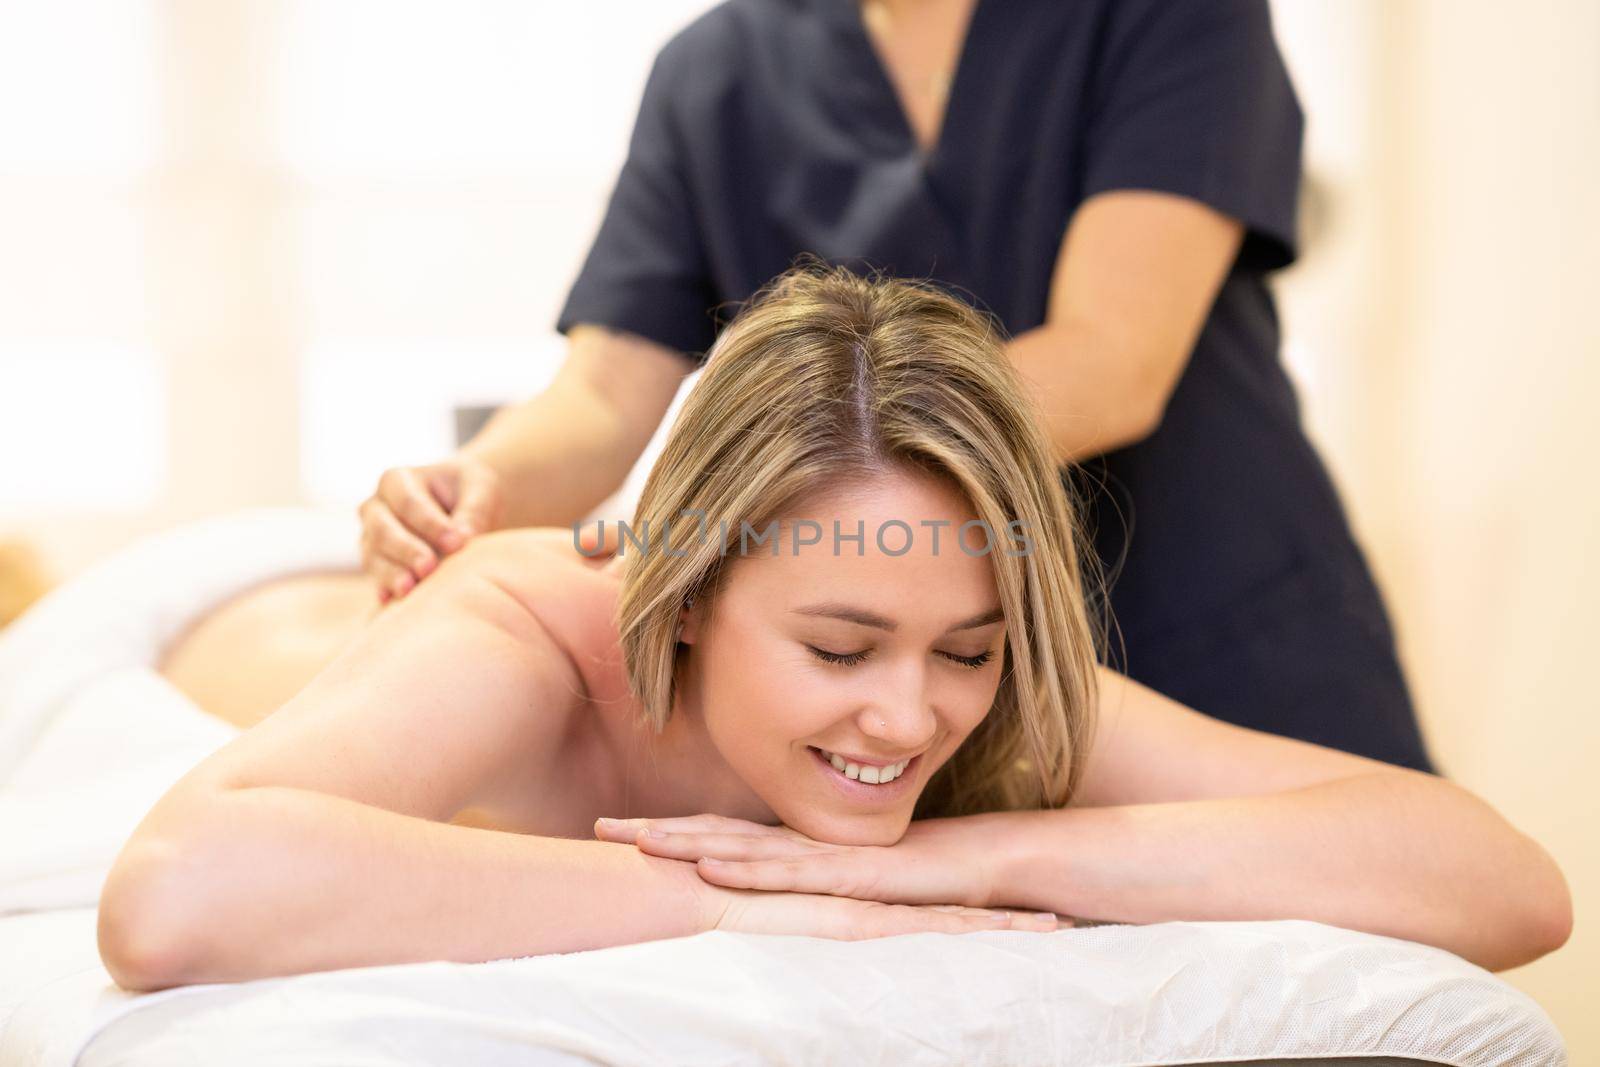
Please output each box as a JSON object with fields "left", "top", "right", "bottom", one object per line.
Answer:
{"left": 595, "top": 814, "right": 1030, "bottom": 907}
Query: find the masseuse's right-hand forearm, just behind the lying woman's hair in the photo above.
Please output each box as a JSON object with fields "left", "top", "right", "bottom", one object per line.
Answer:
{"left": 1006, "top": 320, "right": 1181, "bottom": 464}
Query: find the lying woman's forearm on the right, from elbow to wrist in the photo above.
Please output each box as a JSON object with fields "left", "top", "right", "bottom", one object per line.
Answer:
{"left": 990, "top": 771, "right": 1571, "bottom": 969}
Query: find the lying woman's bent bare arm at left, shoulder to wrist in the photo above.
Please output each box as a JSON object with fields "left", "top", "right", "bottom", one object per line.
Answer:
{"left": 99, "top": 531, "right": 706, "bottom": 989}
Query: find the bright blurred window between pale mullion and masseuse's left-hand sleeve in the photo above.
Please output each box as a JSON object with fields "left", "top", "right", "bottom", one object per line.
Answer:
{"left": 274, "top": 0, "right": 714, "bottom": 504}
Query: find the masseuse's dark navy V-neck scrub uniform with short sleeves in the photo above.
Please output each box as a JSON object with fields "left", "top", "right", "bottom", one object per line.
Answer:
{"left": 557, "top": 0, "right": 1430, "bottom": 769}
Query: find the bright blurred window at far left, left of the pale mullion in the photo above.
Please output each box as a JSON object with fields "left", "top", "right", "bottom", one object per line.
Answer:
{"left": 0, "top": 0, "right": 166, "bottom": 517}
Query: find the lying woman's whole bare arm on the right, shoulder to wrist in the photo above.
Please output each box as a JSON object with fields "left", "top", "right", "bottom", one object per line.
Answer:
{"left": 990, "top": 669, "right": 1573, "bottom": 969}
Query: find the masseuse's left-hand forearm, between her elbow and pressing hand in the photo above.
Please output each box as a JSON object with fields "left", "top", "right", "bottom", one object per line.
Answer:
{"left": 461, "top": 378, "right": 636, "bottom": 528}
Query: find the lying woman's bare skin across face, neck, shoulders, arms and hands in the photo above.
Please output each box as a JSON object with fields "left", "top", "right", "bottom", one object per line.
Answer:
{"left": 112, "top": 478, "right": 1571, "bottom": 989}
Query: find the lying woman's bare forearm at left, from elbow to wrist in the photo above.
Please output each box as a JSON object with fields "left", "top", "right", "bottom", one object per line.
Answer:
{"left": 99, "top": 785, "right": 710, "bottom": 989}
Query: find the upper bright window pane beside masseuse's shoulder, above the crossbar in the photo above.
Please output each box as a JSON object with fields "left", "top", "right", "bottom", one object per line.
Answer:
{"left": 277, "top": 0, "right": 712, "bottom": 179}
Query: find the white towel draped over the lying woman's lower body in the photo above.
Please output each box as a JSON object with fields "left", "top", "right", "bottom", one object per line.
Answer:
{"left": 0, "top": 509, "right": 360, "bottom": 915}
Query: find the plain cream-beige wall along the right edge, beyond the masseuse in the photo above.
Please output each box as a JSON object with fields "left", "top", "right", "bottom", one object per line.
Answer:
{"left": 1390, "top": 0, "right": 1600, "bottom": 1064}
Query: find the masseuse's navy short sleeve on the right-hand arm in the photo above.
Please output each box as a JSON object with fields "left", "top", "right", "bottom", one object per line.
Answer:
{"left": 1083, "top": 0, "right": 1304, "bottom": 270}
